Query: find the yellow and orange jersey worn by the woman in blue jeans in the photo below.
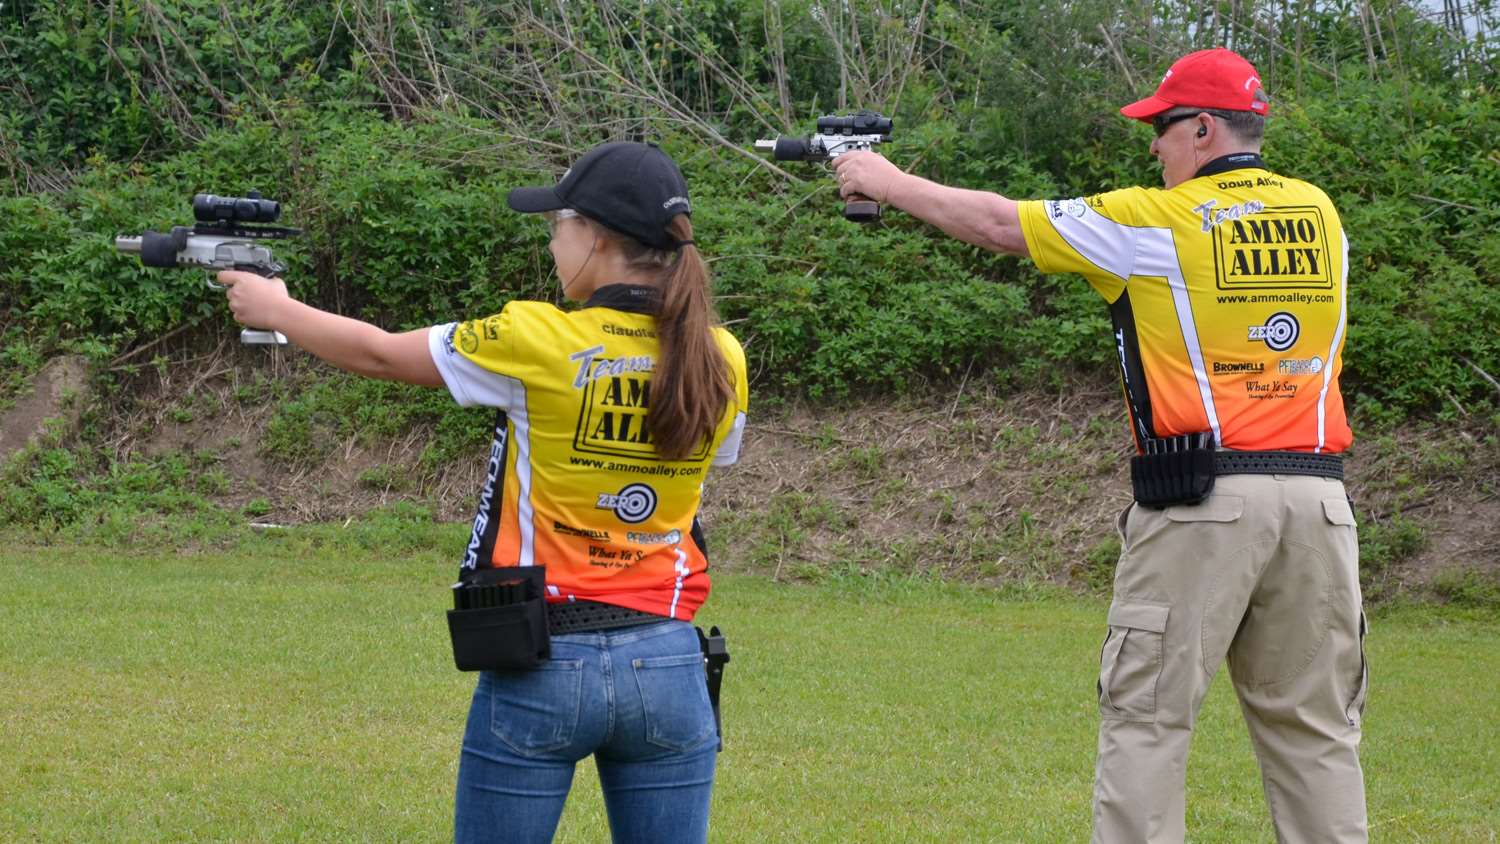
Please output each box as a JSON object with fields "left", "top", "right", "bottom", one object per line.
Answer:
{"left": 428, "top": 285, "right": 749, "bottom": 619}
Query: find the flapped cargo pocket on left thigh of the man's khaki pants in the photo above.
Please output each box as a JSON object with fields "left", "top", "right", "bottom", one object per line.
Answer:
{"left": 1098, "top": 601, "right": 1169, "bottom": 723}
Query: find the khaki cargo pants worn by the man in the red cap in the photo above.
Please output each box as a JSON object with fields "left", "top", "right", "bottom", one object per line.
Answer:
{"left": 1094, "top": 475, "right": 1367, "bottom": 844}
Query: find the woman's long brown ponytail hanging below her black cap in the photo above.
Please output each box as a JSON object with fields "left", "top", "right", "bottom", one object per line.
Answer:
{"left": 585, "top": 214, "right": 735, "bottom": 460}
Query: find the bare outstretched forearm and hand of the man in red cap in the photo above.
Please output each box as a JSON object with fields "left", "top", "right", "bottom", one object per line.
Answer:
{"left": 833, "top": 151, "right": 1031, "bottom": 256}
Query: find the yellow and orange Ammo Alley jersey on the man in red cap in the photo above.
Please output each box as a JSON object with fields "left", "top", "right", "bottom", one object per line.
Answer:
{"left": 1020, "top": 154, "right": 1353, "bottom": 453}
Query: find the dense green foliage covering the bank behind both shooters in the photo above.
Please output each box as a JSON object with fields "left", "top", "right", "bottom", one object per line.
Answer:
{"left": 0, "top": 0, "right": 1500, "bottom": 560}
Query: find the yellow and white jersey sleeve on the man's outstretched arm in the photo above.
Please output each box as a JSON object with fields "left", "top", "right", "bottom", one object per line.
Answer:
{"left": 1019, "top": 187, "right": 1143, "bottom": 301}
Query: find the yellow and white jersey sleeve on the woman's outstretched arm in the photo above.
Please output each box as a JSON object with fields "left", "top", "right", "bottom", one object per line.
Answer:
{"left": 428, "top": 306, "right": 516, "bottom": 408}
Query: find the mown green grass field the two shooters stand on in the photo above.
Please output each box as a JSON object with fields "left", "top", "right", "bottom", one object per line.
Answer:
{"left": 0, "top": 541, "right": 1500, "bottom": 843}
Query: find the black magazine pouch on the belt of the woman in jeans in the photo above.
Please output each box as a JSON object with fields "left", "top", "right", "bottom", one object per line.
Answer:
{"left": 449, "top": 565, "right": 552, "bottom": 672}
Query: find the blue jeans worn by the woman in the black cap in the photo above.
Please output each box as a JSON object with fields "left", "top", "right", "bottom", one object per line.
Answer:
{"left": 455, "top": 621, "right": 719, "bottom": 844}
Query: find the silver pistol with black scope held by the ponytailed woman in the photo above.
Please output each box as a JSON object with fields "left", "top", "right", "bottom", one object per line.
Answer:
{"left": 114, "top": 190, "right": 302, "bottom": 346}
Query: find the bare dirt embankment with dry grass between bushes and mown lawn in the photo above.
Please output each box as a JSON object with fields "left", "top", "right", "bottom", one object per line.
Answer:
{"left": 14, "top": 360, "right": 1500, "bottom": 594}
